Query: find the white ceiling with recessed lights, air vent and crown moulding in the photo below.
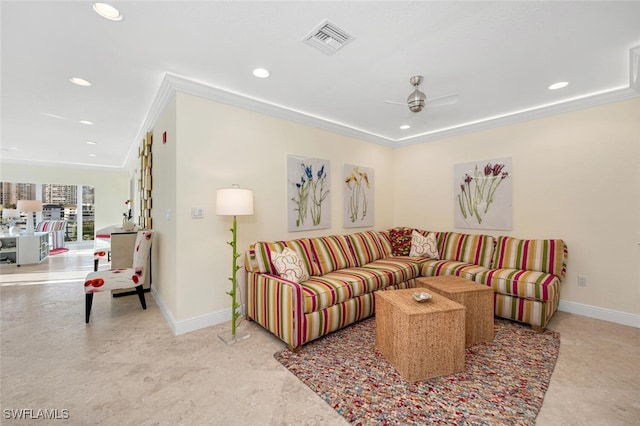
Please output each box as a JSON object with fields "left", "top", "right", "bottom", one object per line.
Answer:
{"left": 0, "top": 0, "right": 640, "bottom": 168}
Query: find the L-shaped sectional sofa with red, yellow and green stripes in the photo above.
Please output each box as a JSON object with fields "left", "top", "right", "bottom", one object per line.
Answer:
{"left": 245, "top": 228, "right": 567, "bottom": 349}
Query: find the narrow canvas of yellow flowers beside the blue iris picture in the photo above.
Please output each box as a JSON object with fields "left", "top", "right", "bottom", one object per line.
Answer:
{"left": 343, "top": 164, "right": 375, "bottom": 228}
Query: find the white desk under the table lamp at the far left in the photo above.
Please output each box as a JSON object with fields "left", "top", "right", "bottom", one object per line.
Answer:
{"left": 0, "top": 232, "right": 49, "bottom": 266}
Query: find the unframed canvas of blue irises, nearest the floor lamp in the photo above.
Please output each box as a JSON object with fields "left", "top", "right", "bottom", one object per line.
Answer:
{"left": 287, "top": 155, "right": 331, "bottom": 232}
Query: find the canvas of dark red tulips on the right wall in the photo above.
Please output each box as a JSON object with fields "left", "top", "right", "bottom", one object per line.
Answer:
{"left": 453, "top": 158, "right": 513, "bottom": 231}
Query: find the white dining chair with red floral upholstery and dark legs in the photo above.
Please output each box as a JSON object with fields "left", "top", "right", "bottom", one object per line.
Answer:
{"left": 84, "top": 230, "right": 153, "bottom": 323}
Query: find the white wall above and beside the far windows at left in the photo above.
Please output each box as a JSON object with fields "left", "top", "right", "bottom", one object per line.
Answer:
{"left": 0, "top": 162, "right": 129, "bottom": 233}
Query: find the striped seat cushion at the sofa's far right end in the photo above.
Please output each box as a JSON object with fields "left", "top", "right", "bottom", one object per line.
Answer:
{"left": 475, "top": 269, "right": 560, "bottom": 301}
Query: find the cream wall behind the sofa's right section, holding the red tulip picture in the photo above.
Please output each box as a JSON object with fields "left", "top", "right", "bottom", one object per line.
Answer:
{"left": 394, "top": 98, "right": 640, "bottom": 315}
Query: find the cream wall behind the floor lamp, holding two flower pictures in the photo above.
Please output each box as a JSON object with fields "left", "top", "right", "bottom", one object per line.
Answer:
{"left": 153, "top": 93, "right": 393, "bottom": 329}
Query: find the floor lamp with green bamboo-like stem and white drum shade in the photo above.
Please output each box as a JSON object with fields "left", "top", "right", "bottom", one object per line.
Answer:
{"left": 216, "top": 185, "right": 253, "bottom": 345}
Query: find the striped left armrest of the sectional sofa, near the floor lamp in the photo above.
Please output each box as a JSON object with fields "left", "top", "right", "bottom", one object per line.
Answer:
{"left": 247, "top": 272, "right": 306, "bottom": 349}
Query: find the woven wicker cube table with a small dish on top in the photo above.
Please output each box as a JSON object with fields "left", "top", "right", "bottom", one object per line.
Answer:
{"left": 375, "top": 289, "right": 465, "bottom": 382}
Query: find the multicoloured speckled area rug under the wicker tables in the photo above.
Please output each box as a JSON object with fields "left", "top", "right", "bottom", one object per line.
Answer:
{"left": 274, "top": 318, "right": 560, "bottom": 425}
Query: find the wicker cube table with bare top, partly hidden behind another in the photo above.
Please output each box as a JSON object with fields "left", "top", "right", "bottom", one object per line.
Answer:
{"left": 416, "top": 275, "right": 494, "bottom": 346}
